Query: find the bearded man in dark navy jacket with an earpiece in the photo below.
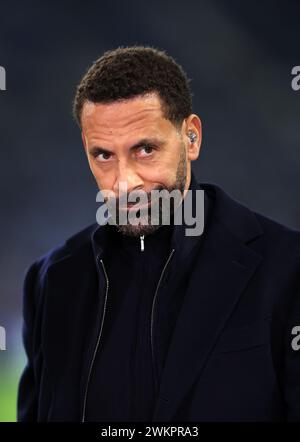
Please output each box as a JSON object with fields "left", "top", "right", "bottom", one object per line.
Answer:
{"left": 18, "top": 47, "right": 300, "bottom": 421}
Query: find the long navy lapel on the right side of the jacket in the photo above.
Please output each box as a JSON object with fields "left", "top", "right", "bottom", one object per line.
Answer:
{"left": 153, "top": 207, "right": 261, "bottom": 421}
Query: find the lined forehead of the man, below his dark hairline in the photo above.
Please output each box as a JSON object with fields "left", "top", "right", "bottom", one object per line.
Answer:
{"left": 81, "top": 93, "right": 168, "bottom": 134}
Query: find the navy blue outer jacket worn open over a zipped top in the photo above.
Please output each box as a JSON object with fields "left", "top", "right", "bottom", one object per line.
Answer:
{"left": 18, "top": 176, "right": 300, "bottom": 422}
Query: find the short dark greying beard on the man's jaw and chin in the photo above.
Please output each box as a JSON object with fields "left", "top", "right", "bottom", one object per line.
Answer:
{"left": 106, "top": 142, "right": 187, "bottom": 237}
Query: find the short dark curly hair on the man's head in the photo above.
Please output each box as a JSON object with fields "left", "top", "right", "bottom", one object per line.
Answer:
{"left": 73, "top": 46, "right": 192, "bottom": 127}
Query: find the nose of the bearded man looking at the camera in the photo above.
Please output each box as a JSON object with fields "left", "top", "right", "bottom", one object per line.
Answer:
{"left": 113, "top": 161, "right": 144, "bottom": 194}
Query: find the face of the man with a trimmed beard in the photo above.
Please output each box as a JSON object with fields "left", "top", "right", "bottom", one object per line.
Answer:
{"left": 81, "top": 93, "right": 198, "bottom": 236}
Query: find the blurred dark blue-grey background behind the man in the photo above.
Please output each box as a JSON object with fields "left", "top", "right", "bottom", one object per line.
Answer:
{"left": 0, "top": 0, "right": 300, "bottom": 420}
